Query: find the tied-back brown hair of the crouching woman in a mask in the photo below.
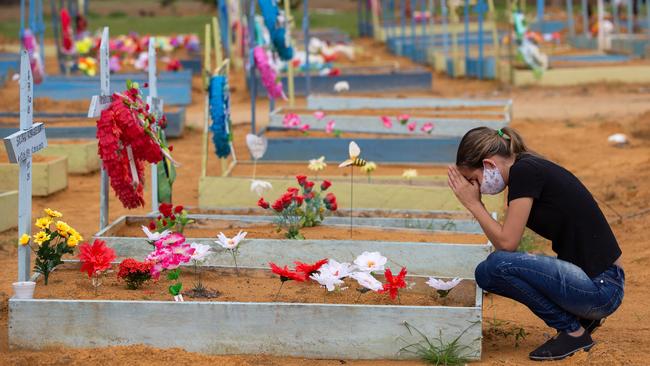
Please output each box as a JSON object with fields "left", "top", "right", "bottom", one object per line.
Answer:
{"left": 456, "top": 127, "right": 533, "bottom": 169}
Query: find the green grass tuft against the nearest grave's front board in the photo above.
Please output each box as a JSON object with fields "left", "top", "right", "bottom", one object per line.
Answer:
{"left": 399, "top": 322, "right": 478, "bottom": 366}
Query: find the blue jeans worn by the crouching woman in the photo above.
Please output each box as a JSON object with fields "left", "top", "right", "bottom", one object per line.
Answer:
{"left": 475, "top": 251, "right": 625, "bottom": 332}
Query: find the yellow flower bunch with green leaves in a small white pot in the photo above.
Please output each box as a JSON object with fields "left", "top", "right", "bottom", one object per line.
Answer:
{"left": 18, "top": 208, "right": 83, "bottom": 285}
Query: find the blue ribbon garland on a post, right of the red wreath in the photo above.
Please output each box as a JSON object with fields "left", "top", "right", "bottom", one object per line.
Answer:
{"left": 209, "top": 76, "right": 230, "bottom": 158}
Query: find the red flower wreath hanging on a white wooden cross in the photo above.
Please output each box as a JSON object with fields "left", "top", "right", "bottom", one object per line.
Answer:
{"left": 97, "top": 83, "right": 166, "bottom": 208}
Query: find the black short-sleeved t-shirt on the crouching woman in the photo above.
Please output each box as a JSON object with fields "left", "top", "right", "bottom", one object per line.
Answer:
{"left": 508, "top": 154, "right": 621, "bottom": 277}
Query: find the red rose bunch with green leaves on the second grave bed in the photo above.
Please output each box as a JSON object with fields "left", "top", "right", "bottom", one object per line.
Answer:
{"left": 257, "top": 175, "right": 338, "bottom": 239}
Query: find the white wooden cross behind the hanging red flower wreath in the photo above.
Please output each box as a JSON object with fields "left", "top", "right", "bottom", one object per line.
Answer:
{"left": 88, "top": 27, "right": 113, "bottom": 230}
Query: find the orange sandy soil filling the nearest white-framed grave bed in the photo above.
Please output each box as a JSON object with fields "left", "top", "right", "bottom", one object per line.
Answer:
{"left": 34, "top": 265, "right": 475, "bottom": 306}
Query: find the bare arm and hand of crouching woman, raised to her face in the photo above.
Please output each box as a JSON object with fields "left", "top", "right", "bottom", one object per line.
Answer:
{"left": 448, "top": 167, "right": 533, "bottom": 252}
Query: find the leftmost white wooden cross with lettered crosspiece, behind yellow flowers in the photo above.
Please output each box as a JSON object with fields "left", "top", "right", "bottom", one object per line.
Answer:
{"left": 4, "top": 50, "right": 47, "bottom": 281}
